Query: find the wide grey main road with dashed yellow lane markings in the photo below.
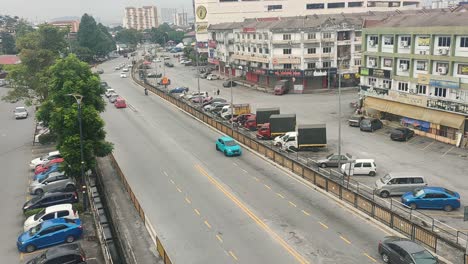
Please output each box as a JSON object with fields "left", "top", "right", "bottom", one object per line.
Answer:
{"left": 101, "top": 58, "right": 394, "bottom": 263}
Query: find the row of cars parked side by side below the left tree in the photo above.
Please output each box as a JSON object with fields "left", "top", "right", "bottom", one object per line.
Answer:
{"left": 16, "top": 151, "right": 86, "bottom": 264}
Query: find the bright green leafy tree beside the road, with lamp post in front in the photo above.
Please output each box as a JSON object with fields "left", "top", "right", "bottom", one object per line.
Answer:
{"left": 37, "top": 54, "right": 113, "bottom": 176}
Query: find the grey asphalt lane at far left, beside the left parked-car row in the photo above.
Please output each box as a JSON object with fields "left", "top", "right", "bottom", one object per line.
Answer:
{"left": 0, "top": 87, "right": 34, "bottom": 263}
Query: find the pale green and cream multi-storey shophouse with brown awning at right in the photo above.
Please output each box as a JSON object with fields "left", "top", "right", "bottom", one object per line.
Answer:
{"left": 359, "top": 11, "right": 468, "bottom": 146}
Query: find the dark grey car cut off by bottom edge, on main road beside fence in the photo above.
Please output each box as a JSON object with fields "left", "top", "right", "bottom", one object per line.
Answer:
{"left": 378, "top": 236, "right": 439, "bottom": 264}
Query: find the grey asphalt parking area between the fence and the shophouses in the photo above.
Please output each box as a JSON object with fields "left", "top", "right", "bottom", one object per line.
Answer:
{"left": 152, "top": 55, "right": 468, "bottom": 231}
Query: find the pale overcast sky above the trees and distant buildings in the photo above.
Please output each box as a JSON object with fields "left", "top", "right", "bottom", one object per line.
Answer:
{"left": 0, "top": 0, "right": 192, "bottom": 24}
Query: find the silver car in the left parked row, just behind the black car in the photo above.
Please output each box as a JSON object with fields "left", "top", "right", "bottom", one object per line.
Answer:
{"left": 29, "top": 172, "right": 76, "bottom": 195}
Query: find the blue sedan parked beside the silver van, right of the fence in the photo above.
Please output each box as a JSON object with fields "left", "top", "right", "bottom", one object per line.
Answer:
{"left": 401, "top": 187, "right": 460, "bottom": 212}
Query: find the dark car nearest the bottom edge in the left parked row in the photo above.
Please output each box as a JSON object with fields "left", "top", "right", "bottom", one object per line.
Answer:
{"left": 26, "top": 243, "right": 86, "bottom": 264}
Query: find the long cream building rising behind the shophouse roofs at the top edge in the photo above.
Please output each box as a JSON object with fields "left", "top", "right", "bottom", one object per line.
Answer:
{"left": 193, "top": 0, "right": 422, "bottom": 52}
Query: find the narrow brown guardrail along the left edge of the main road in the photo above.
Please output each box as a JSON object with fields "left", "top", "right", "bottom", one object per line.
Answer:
{"left": 109, "top": 153, "right": 172, "bottom": 264}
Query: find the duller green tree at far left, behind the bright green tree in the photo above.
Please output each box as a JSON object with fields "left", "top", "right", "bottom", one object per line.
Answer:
{"left": 2, "top": 24, "right": 67, "bottom": 103}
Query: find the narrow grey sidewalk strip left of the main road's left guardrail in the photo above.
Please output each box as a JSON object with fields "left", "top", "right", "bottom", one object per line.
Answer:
{"left": 97, "top": 157, "right": 163, "bottom": 264}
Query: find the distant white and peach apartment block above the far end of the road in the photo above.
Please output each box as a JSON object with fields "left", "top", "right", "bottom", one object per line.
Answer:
{"left": 123, "top": 6, "right": 159, "bottom": 30}
